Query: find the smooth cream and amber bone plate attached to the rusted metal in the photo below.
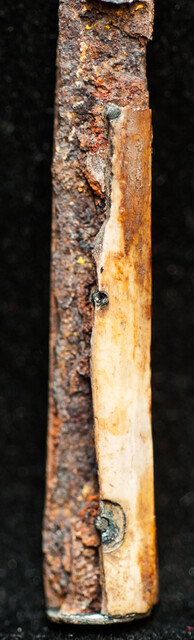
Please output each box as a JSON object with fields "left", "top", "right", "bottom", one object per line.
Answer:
{"left": 91, "top": 107, "right": 157, "bottom": 616}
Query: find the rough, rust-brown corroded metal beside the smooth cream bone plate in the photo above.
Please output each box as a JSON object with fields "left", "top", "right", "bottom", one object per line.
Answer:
{"left": 43, "top": 0, "right": 156, "bottom": 623}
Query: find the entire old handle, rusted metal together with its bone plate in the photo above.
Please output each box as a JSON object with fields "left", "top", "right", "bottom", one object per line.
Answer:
{"left": 43, "top": 0, "right": 157, "bottom": 624}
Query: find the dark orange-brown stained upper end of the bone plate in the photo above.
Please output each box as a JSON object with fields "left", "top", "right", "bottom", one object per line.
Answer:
{"left": 115, "top": 109, "right": 152, "bottom": 258}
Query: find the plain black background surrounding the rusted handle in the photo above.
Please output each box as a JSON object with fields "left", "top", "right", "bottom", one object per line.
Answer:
{"left": 0, "top": 0, "right": 194, "bottom": 640}
